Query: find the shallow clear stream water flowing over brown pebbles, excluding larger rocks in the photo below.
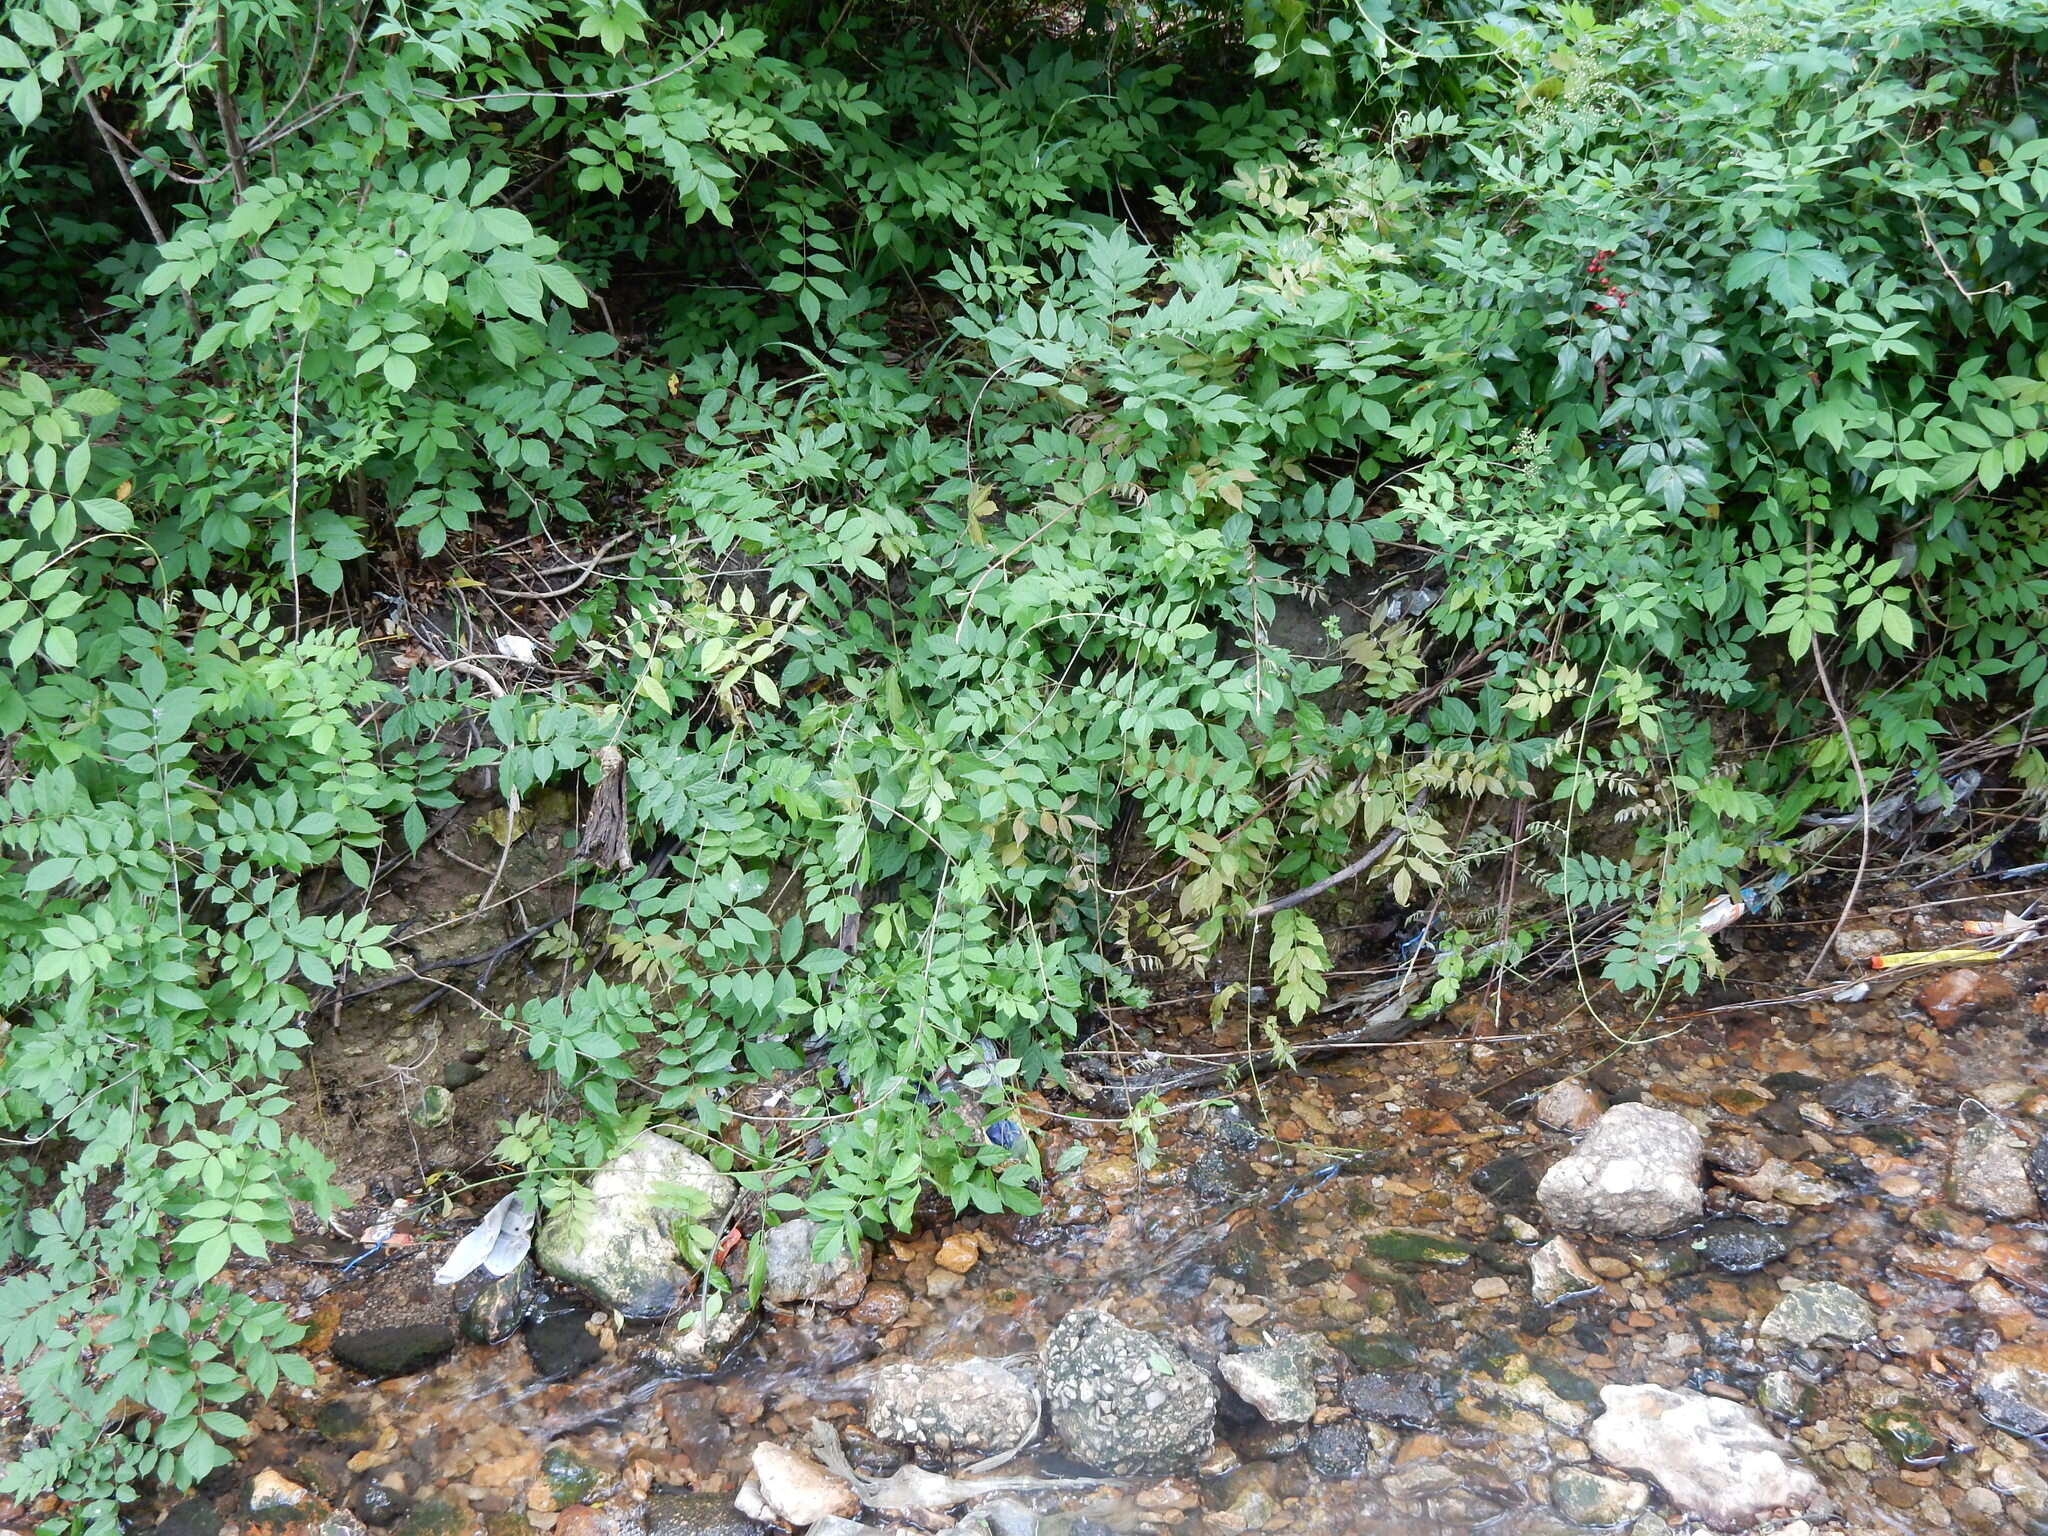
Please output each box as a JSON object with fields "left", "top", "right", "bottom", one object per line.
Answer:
{"left": 155, "top": 876, "right": 2048, "bottom": 1536}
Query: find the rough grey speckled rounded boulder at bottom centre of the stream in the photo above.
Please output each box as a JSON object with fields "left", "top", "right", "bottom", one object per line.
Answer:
{"left": 1042, "top": 1307, "right": 1217, "bottom": 1475}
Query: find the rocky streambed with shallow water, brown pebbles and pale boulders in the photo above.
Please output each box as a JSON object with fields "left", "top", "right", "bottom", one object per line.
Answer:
{"left": 132, "top": 905, "right": 2048, "bottom": 1536}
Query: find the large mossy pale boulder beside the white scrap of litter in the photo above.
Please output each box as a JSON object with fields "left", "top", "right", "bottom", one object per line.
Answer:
{"left": 535, "top": 1130, "right": 737, "bottom": 1317}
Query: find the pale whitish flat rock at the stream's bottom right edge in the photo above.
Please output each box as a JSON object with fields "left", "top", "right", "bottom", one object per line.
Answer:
{"left": 1585, "top": 1386, "right": 1823, "bottom": 1532}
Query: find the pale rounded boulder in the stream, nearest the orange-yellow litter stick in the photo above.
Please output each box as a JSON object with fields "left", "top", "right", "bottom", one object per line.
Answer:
{"left": 1536, "top": 1104, "right": 1704, "bottom": 1237}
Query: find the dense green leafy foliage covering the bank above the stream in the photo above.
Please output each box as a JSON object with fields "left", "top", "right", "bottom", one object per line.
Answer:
{"left": 0, "top": 0, "right": 2048, "bottom": 1530}
